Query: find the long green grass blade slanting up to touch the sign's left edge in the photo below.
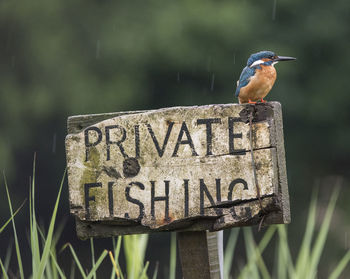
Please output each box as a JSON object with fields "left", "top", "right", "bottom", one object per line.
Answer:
{"left": 38, "top": 170, "right": 66, "bottom": 279}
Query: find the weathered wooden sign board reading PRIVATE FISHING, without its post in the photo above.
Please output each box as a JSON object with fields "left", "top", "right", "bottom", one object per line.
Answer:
{"left": 66, "top": 102, "right": 290, "bottom": 238}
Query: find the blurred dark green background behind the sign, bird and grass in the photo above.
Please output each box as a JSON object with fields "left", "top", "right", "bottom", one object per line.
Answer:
{"left": 0, "top": 0, "right": 350, "bottom": 275}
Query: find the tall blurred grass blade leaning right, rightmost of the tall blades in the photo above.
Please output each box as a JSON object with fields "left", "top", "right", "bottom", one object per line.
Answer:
{"left": 306, "top": 187, "right": 339, "bottom": 278}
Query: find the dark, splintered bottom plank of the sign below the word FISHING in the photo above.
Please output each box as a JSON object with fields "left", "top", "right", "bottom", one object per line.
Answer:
{"left": 76, "top": 196, "right": 283, "bottom": 239}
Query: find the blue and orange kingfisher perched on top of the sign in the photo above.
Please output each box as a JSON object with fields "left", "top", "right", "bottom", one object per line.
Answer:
{"left": 235, "top": 50, "right": 296, "bottom": 104}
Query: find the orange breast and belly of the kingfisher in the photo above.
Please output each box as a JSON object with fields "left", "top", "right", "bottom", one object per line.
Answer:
{"left": 238, "top": 65, "right": 277, "bottom": 103}
